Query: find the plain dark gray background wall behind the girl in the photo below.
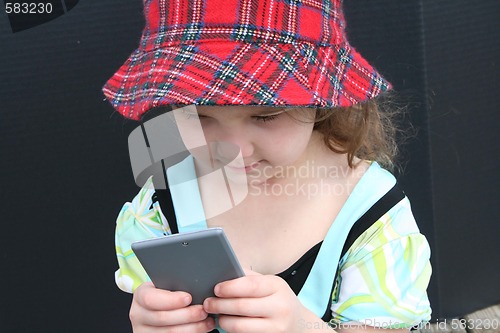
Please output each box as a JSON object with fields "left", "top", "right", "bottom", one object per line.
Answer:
{"left": 0, "top": 0, "right": 500, "bottom": 333}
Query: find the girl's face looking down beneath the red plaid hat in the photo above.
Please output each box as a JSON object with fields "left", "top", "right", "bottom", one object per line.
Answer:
{"left": 174, "top": 106, "right": 315, "bottom": 185}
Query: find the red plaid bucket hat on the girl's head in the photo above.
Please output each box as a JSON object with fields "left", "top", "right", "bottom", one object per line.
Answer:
{"left": 103, "top": 0, "right": 390, "bottom": 120}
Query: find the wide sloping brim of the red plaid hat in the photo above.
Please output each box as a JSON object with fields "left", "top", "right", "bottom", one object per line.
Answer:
{"left": 103, "top": 40, "right": 391, "bottom": 120}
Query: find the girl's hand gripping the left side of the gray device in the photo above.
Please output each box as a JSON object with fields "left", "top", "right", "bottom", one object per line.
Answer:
{"left": 130, "top": 282, "right": 215, "bottom": 333}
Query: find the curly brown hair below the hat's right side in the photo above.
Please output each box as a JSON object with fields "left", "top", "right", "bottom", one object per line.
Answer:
{"left": 314, "top": 94, "right": 402, "bottom": 170}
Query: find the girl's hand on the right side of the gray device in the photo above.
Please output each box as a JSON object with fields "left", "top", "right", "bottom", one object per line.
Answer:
{"left": 203, "top": 272, "right": 308, "bottom": 333}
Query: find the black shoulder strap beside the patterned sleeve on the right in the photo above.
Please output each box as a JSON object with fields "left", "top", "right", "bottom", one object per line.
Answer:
{"left": 322, "top": 183, "right": 405, "bottom": 322}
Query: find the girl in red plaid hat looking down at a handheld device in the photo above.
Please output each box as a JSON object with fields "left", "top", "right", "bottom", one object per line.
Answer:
{"left": 103, "top": 0, "right": 431, "bottom": 333}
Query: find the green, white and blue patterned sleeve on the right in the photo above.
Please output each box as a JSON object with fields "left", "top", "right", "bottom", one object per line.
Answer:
{"left": 331, "top": 198, "right": 432, "bottom": 328}
